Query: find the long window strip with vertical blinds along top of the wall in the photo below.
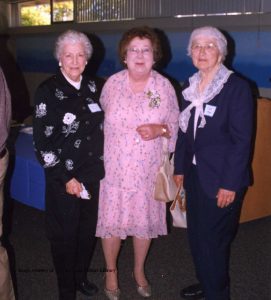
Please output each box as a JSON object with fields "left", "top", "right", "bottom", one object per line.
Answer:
{"left": 6, "top": 0, "right": 271, "bottom": 26}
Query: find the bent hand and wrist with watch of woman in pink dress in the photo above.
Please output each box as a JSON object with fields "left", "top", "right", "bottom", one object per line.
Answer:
{"left": 136, "top": 124, "right": 170, "bottom": 141}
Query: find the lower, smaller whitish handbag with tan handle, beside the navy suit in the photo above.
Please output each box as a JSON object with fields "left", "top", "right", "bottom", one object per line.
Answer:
{"left": 170, "top": 185, "right": 187, "bottom": 228}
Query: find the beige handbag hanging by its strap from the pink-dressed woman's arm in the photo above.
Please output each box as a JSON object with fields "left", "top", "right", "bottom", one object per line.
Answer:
{"left": 154, "top": 138, "right": 177, "bottom": 202}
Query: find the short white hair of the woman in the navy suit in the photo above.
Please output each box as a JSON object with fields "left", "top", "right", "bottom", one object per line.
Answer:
{"left": 187, "top": 26, "right": 228, "bottom": 61}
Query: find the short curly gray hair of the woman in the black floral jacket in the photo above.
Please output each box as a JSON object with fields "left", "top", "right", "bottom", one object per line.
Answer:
{"left": 54, "top": 30, "right": 93, "bottom": 61}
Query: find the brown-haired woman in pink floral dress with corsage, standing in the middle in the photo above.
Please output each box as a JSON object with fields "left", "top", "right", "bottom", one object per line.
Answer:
{"left": 96, "top": 27, "right": 179, "bottom": 300}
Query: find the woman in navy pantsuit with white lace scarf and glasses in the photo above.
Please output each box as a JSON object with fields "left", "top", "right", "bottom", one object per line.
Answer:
{"left": 175, "top": 27, "right": 253, "bottom": 300}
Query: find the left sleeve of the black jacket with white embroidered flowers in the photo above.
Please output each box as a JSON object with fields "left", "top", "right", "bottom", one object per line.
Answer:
{"left": 33, "top": 84, "right": 73, "bottom": 184}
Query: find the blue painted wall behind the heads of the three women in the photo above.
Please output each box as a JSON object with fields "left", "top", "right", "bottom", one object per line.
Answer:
{"left": 16, "top": 31, "right": 271, "bottom": 88}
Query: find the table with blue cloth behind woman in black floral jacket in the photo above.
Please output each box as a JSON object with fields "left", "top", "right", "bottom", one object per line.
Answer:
{"left": 10, "top": 132, "right": 45, "bottom": 210}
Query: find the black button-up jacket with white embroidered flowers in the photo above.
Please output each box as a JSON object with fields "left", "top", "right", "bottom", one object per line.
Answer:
{"left": 33, "top": 71, "right": 104, "bottom": 184}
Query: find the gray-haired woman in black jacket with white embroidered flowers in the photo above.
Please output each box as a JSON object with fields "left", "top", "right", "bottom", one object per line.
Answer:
{"left": 34, "top": 30, "right": 104, "bottom": 300}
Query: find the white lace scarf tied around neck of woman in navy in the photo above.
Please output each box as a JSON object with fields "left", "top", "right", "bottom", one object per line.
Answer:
{"left": 179, "top": 64, "right": 233, "bottom": 132}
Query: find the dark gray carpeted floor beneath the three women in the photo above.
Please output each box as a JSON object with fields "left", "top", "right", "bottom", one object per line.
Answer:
{"left": 3, "top": 200, "right": 271, "bottom": 300}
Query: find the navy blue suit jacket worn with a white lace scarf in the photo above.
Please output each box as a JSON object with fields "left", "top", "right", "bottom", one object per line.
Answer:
{"left": 175, "top": 73, "right": 254, "bottom": 197}
